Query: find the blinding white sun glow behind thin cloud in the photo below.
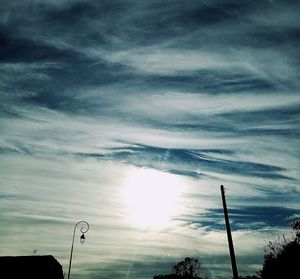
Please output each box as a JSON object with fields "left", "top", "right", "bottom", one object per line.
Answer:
{"left": 124, "top": 169, "right": 181, "bottom": 228}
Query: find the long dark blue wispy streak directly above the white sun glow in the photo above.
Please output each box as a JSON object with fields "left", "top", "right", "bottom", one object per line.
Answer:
{"left": 73, "top": 144, "right": 290, "bottom": 179}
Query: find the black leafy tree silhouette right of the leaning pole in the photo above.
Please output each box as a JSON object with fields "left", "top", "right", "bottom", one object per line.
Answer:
{"left": 259, "top": 219, "right": 300, "bottom": 279}
